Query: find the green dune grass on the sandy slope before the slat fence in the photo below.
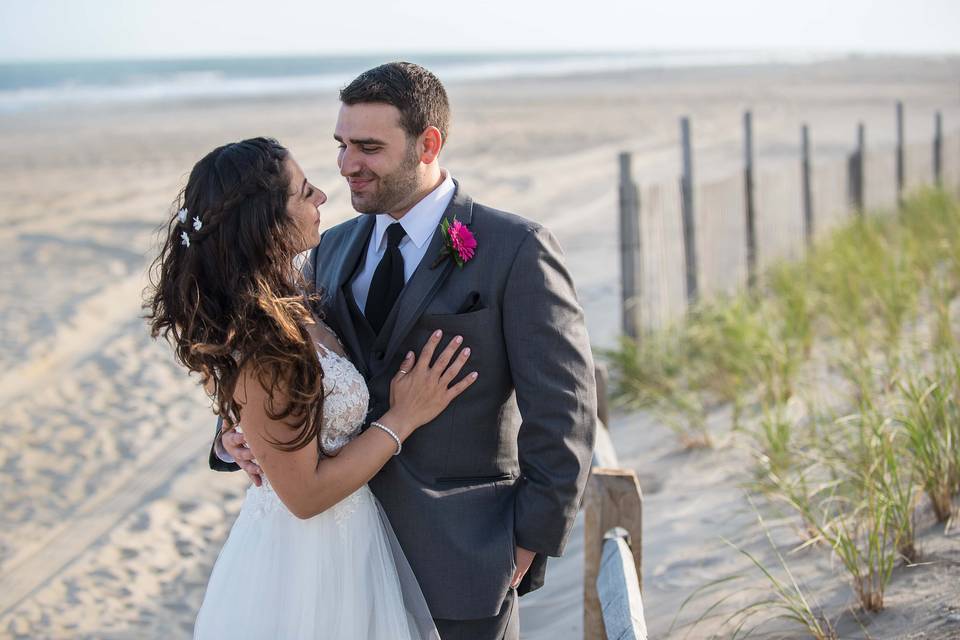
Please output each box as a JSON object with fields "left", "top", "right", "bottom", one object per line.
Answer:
{"left": 603, "top": 190, "right": 960, "bottom": 624}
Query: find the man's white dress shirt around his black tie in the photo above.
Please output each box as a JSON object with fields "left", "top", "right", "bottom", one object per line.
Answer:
{"left": 350, "top": 169, "right": 455, "bottom": 312}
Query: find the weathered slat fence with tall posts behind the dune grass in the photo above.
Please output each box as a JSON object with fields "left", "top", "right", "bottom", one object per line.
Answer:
{"left": 619, "top": 103, "right": 960, "bottom": 338}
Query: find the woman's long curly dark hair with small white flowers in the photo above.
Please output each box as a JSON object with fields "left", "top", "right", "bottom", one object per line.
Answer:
{"left": 144, "top": 138, "right": 324, "bottom": 453}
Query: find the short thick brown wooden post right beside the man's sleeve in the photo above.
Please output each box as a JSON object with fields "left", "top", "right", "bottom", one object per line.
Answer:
{"left": 583, "top": 467, "right": 643, "bottom": 640}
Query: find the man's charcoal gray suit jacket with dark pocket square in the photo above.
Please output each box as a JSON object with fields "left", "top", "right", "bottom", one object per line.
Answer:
{"left": 211, "top": 184, "right": 596, "bottom": 620}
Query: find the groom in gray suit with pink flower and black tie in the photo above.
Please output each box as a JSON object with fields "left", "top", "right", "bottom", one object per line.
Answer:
{"left": 210, "top": 62, "right": 596, "bottom": 640}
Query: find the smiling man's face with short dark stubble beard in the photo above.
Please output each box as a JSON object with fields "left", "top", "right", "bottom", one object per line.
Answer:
{"left": 333, "top": 103, "right": 420, "bottom": 213}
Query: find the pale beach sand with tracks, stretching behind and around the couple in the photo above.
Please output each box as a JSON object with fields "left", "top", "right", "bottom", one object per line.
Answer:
{"left": 0, "top": 58, "right": 960, "bottom": 640}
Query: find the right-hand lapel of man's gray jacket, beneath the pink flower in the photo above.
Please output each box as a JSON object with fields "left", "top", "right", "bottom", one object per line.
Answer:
{"left": 383, "top": 180, "right": 473, "bottom": 362}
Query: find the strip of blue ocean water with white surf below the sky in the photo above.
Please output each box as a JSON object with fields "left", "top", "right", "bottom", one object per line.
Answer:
{"left": 0, "top": 51, "right": 813, "bottom": 113}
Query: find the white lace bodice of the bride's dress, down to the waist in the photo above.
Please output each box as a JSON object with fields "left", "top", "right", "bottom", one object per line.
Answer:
{"left": 242, "top": 325, "right": 372, "bottom": 522}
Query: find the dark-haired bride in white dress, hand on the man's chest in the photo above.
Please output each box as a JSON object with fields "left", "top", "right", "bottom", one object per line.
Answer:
{"left": 146, "top": 138, "right": 476, "bottom": 640}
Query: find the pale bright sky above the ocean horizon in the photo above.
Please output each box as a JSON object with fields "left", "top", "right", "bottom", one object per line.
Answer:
{"left": 0, "top": 0, "right": 960, "bottom": 62}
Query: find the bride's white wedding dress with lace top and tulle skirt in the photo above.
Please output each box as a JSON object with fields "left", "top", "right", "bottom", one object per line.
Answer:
{"left": 193, "top": 338, "right": 439, "bottom": 640}
